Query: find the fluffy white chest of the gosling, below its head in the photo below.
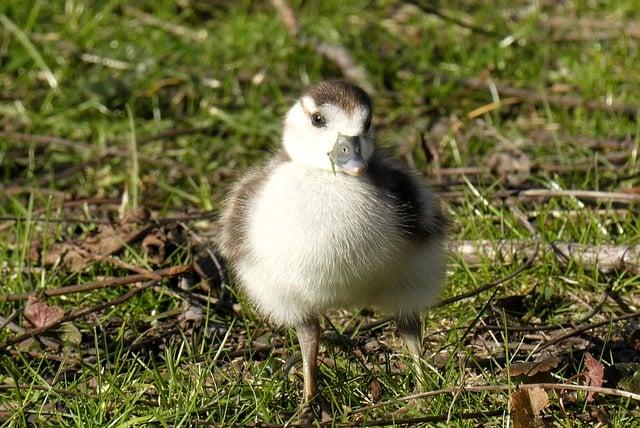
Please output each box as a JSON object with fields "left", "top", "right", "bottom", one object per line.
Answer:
{"left": 245, "top": 163, "right": 403, "bottom": 306}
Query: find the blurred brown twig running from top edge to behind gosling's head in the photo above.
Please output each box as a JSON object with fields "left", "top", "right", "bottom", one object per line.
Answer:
{"left": 271, "top": 0, "right": 375, "bottom": 93}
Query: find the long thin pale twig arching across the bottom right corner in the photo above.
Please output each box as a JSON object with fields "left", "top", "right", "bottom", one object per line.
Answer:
{"left": 349, "top": 383, "right": 640, "bottom": 415}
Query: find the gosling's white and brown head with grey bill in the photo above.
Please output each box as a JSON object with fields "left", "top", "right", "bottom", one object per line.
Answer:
{"left": 282, "top": 80, "right": 375, "bottom": 176}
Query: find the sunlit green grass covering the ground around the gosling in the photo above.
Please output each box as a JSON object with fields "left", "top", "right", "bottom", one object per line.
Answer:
{"left": 0, "top": 0, "right": 640, "bottom": 427}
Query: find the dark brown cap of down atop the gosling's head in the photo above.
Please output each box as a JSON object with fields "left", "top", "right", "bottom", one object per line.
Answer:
{"left": 303, "top": 80, "right": 371, "bottom": 122}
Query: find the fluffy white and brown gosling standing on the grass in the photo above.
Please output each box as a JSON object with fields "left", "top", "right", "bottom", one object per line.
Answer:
{"left": 219, "top": 81, "right": 447, "bottom": 402}
